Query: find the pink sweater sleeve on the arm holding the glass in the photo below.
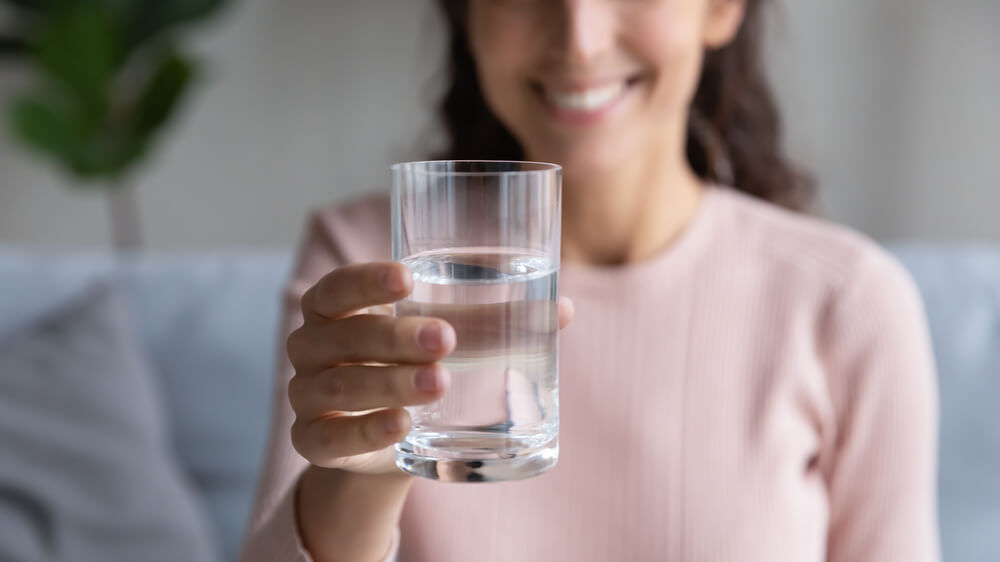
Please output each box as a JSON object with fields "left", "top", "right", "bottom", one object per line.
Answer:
{"left": 239, "top": 214, "right": 399, "bottom": 562}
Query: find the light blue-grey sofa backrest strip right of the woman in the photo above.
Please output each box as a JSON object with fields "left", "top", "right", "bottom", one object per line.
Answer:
{"left": 892, "top": 244, "right": 1000, "bottom": 562}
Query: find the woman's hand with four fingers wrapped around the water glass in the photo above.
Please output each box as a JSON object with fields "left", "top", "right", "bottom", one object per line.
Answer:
{"left": 288, "top": 262, "right": 456, "bottom": 474}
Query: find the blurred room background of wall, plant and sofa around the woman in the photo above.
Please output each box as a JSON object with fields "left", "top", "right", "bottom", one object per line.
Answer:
{"left": 0, "top": 0, "right": 1000, "bottom": 562}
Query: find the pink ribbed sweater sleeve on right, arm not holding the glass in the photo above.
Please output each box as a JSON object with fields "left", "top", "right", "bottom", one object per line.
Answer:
{"left": 820, "top": 250, "right": 940, "bottom": 562}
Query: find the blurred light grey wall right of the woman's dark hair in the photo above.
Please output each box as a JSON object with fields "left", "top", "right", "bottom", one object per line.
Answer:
{"left": 771, "top": 0, "right": 1000, "bottom": 241}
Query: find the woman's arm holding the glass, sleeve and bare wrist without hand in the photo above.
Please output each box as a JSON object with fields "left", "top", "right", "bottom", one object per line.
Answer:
{"left": 240, "top": 211, "right": 409, "bottom": 562}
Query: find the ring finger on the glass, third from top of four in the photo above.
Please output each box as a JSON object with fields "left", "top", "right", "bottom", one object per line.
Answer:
{"left": 288, "top": 365, "right": 451, "bottom": 418}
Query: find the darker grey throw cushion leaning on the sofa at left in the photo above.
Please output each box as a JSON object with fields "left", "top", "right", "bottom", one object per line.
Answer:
{"left": 0, "top": 283, "right": 218, "bottom": 562}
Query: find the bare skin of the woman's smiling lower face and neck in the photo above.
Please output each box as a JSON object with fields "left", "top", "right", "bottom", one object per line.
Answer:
{"left": 469, "top": 0, "right": 743, "bottom": 264}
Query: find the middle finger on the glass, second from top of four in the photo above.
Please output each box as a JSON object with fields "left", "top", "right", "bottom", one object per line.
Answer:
{"left": 287, "top": 314, "right": 456, "bottom": 372}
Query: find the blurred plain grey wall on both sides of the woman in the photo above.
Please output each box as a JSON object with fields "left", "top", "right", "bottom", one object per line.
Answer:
{"left": 0, "top": 0, "right": 1000, "bottom": 250}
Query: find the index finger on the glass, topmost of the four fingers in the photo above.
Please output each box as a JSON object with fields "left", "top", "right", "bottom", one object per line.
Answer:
{"left": 302, "top": 262, "right": 413, "bottom": 322}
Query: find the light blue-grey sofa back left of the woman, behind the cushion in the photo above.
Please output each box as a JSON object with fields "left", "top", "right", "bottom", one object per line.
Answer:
{"left": 0, "top": 252, "right": 291, "bottom": 560}
